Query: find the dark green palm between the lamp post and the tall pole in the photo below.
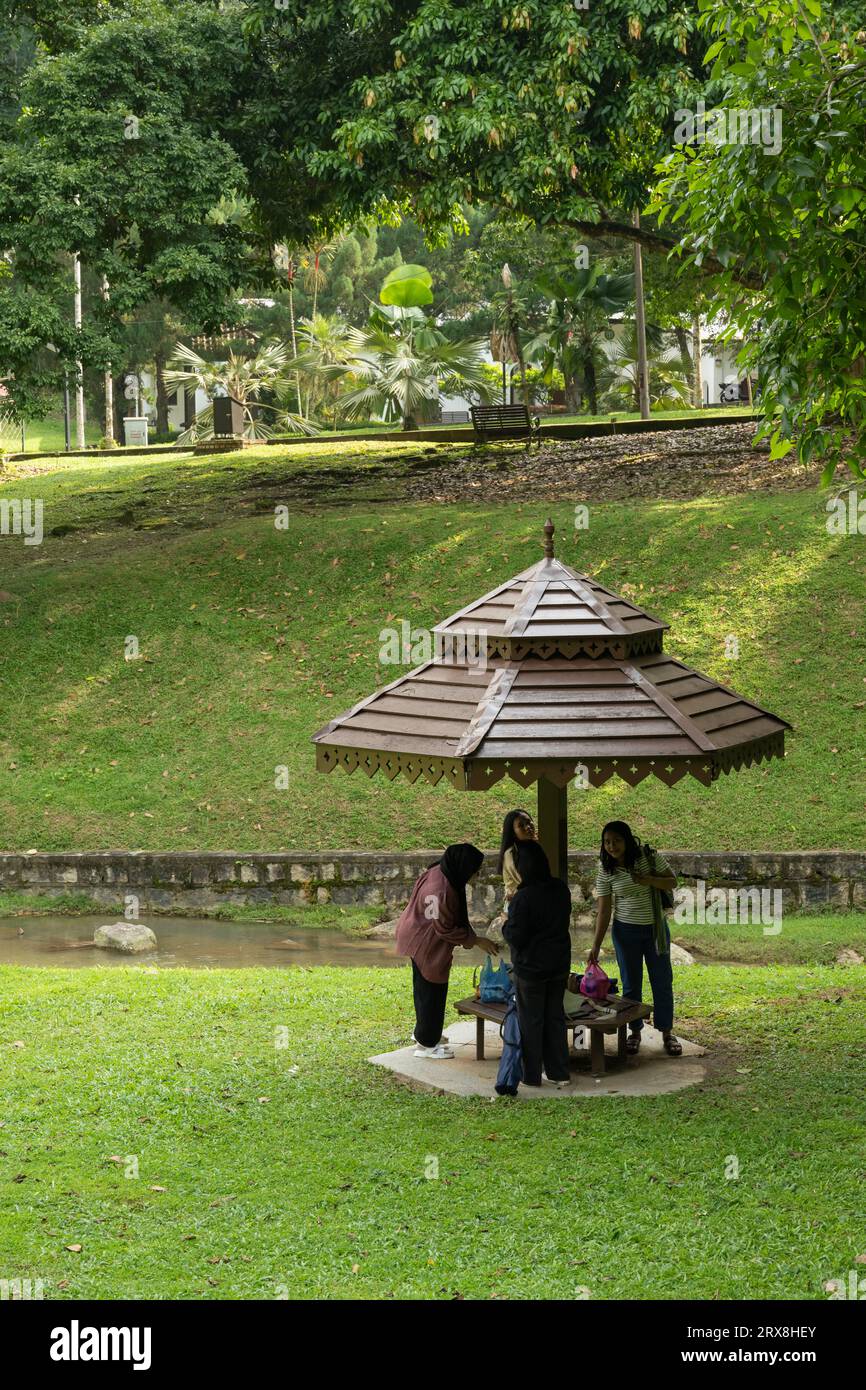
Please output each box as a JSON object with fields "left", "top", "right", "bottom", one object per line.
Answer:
{"left": 524, "top": 261, "right": 634, "bottom": 414}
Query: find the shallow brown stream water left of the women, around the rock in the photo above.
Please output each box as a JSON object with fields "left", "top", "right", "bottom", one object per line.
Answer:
{"left": 0, "top": 915, "right": 403, "bottom": 969}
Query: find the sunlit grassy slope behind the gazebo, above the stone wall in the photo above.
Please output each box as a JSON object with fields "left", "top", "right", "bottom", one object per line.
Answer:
{"left": 0, "top": 443, "right": 866, "bottom": 849}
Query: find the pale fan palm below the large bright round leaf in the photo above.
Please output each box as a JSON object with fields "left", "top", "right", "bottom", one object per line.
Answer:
{"left": 335, "top": 304, "right": 489, "bottom": 430}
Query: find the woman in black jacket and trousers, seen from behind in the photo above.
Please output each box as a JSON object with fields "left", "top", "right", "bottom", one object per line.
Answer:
{"left": 502, "top": 840, "right": 571, "bottom": 1087}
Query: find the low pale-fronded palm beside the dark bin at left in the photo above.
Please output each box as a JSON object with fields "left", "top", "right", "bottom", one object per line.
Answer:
{"left": 165, "top": 342, "right": 318, "bottom": 445}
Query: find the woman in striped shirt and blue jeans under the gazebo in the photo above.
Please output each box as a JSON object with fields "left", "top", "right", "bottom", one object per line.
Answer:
{"left": 588, "top": 820, "right": 683, "bottom": 1056}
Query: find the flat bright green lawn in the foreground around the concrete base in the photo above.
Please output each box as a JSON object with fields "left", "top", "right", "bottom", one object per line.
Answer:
{"left": 0, "top": 966, "right": 866, "bottom": 1300}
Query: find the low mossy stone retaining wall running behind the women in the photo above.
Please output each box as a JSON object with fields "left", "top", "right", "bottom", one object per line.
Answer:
{"left": 0, "top": 849, "right": 866, "bottom": 919}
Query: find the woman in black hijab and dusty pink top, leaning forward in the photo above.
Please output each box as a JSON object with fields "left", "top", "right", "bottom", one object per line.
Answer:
{"left": 396, "top": 844, "right": 498, "bottom": 1062}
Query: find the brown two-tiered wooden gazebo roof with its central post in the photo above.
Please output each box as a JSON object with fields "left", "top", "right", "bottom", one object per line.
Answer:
{"left": 314, "top": 521, "right": 791, "bottom": 877}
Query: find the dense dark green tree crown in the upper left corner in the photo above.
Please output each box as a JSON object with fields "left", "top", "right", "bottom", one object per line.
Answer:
{"left": 0, "top": 3, "right": 249, "bottom": 409}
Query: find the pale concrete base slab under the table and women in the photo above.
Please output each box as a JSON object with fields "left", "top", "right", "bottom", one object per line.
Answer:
{"left": 368, "top": 1019, "right": 706, "bottom": 1101}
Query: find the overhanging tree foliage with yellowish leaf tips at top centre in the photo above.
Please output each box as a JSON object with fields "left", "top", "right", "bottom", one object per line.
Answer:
{"left": 245, "top": 0, "right": 702, "bottom": 245}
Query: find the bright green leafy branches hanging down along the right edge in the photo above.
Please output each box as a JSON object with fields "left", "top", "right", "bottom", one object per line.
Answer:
{"left": 655, "top": 0, "right": 866, "bottom": 477}
